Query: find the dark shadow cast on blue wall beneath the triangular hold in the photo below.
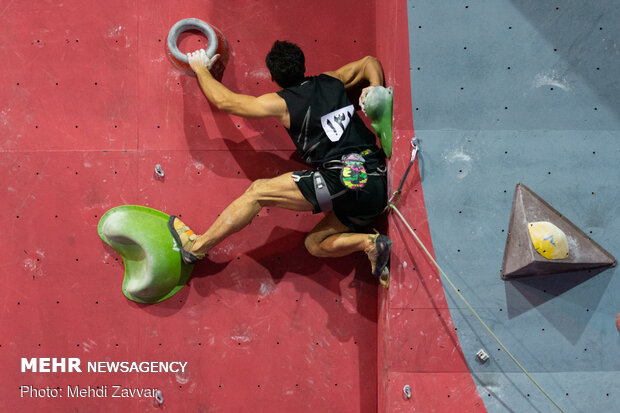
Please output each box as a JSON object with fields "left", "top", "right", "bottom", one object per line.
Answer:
{"left": 505, "top": 268, "right": 615, "bottom": 344}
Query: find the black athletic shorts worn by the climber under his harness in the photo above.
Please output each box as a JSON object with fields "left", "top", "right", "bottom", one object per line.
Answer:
{"left": 293, "top": 168, "right": 387, "bottom": 232}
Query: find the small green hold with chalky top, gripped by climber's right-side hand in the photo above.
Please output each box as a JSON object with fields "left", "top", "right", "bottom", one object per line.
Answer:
{"left": 364, "top": 86, "right": 394, "bottom": 158}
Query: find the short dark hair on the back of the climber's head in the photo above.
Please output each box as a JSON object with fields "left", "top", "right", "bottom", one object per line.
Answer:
{"left": 265, "top": 40, "right": 306, "bottom": 88}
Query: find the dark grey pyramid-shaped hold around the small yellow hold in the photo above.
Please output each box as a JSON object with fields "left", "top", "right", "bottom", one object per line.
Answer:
{"left": 501, "top": 184, "right": 616, "bottom": 280}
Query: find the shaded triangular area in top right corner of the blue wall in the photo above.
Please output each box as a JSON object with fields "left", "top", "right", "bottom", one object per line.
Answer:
{"left": 510, "top": 0, "right": 620, "bottom": 119}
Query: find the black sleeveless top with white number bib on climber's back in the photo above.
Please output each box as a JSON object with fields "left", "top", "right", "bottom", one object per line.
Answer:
{"left": 278, "top": 74, "right": 385, "bottom": 170}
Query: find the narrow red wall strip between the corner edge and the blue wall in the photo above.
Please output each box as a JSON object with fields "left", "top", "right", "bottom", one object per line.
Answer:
{"left": 376, "top": 1, "right": 486, "bottom": 413}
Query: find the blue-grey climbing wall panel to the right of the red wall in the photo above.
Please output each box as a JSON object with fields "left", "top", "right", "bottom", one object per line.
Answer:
{"left": 407, "top": 0, "right": 620, "bottom": 412}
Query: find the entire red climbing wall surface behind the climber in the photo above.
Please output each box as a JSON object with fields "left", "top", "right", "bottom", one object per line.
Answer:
{"left": 0, "top": 0, "right": 484, "bottom": 412}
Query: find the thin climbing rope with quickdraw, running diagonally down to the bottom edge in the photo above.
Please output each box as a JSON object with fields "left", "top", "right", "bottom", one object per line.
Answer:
{"left": 387, "top": 138, "right": 564, "bottom": 413}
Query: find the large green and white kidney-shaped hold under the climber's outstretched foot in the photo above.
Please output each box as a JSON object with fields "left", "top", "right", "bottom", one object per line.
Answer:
{"left": 97, "top": 205, "right": 193, "bottom": 303}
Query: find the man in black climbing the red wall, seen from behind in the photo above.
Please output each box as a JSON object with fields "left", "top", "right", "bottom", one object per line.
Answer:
{"left": 169, "top": 41, "right": 392, "bottom": 285}
